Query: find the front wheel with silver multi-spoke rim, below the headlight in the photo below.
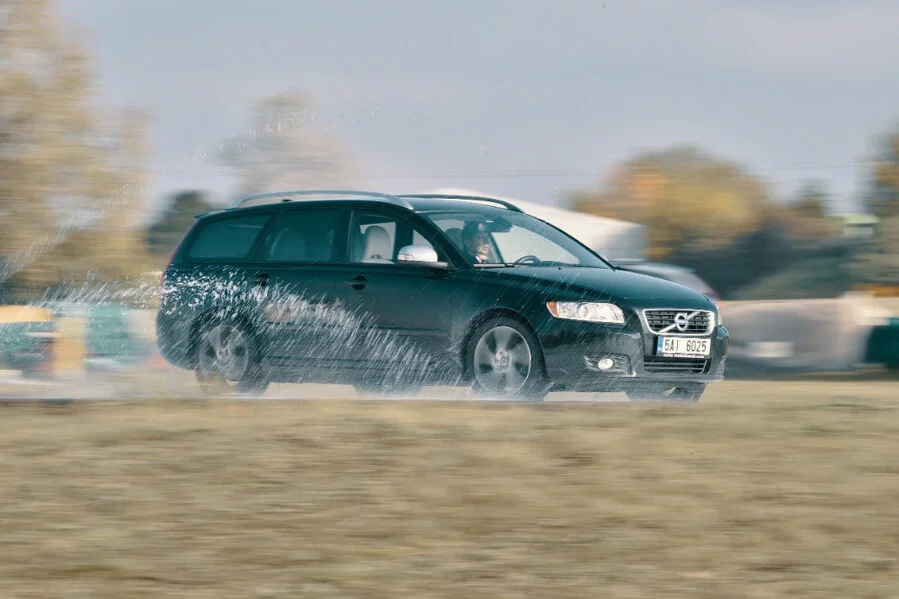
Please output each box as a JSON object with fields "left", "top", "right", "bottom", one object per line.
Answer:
{"left": 466, "top": 316, "right": 551, "bottom": 401}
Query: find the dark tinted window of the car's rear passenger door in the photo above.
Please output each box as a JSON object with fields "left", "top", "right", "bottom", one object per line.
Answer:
{"left": 263, "top": 208, "right": 343, "bottom": 262}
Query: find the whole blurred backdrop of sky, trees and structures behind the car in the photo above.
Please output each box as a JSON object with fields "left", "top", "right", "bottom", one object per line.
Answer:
{"left": 0, "top": 0, "right": 899, "bottom": 378}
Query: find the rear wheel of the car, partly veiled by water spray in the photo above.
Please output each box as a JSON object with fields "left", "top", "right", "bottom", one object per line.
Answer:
{"left": 195, "top": 319, "right": 269, "bottom": 397}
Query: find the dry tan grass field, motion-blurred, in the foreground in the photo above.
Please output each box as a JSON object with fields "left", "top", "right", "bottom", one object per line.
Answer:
{"left": 0, "top": 379, "right": 899, "bottom": 599}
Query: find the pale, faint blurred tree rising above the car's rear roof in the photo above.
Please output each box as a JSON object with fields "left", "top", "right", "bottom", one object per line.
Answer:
{"left": 221, "top": 91, "right": 353, "bottom": 194}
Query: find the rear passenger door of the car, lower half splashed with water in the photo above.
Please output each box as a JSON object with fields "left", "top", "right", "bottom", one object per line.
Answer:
{"left": 255, "top": 204, "right": 351, "bottom": 367}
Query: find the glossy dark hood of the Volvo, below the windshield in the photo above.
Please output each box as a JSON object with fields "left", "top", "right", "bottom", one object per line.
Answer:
{"left": 488, "top": 266, "right": 712, "bottom": 307}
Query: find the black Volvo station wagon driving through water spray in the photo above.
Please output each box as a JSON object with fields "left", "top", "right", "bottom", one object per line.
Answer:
{"left": 156, "top": 190, "right": 728, "bottom": 401}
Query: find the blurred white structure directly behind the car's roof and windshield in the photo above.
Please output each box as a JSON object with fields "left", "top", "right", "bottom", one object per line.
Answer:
{"left": 421, "top": 188, "right": 647, "bottom": 260}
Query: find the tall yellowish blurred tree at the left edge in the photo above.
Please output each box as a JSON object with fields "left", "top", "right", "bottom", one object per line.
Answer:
{"left": 0, "top": 0, "right": 151, "bottom": 287}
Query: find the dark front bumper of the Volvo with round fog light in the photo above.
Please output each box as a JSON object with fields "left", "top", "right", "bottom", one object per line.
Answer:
{"left": 540, "top": 321, "right": 729, "bottom": 392}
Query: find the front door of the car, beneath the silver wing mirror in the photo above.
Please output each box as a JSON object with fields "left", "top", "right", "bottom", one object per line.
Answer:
{"left": 330, "top": 207, "right": 454, "bottom": 367}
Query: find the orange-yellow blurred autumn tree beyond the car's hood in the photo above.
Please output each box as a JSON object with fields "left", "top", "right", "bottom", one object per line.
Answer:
{"left": 572, "top": 146, "right": 769, "bottom": 259}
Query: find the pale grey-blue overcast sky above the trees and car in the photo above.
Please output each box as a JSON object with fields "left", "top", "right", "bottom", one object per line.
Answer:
{"left": 61, "top": 0, "right": 899, "bottom": 220}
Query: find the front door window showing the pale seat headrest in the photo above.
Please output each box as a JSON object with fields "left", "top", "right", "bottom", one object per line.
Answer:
{"left": 349, "top": 211, "right": 446, "bottom": 264}
